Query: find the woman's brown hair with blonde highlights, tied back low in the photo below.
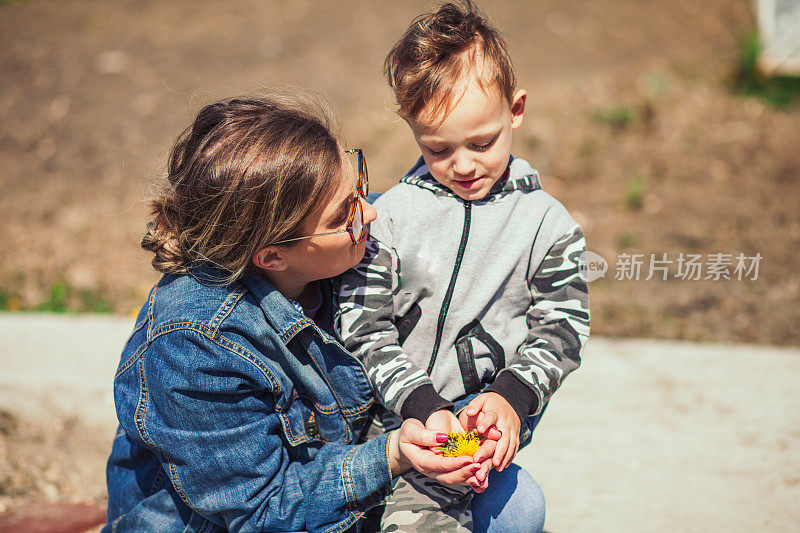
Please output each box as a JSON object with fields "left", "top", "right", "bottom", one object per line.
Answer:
{"left": 142, "top": 91, "right": 342, "bottom": 284}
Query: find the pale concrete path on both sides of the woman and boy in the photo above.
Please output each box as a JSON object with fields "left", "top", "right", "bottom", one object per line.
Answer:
{"left": 0, "top": 314, "right": 800, "bottom": 533}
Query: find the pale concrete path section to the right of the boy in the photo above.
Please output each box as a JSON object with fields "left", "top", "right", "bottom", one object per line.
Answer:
{"left": 517, "top": 338, "right": 800, "bottom": 532}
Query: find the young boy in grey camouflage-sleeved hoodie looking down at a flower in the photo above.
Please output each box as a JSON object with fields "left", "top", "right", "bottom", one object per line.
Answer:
{"left": 340, "top": 1, "right": 589, "bottom": 531}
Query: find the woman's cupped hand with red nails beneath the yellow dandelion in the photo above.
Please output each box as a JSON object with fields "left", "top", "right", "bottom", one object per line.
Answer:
{"left": 389, "top": 418, "right": 481, "bottom": 485}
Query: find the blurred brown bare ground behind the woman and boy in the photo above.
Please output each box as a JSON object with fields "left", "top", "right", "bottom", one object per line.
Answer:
{"left": 0, "top": 0, "right": 800, "bottom": 524}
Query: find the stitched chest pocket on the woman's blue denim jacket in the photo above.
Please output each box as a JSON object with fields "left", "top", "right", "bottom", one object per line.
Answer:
{"left": 278, "top": 390, "right": 353, "bottom": 446}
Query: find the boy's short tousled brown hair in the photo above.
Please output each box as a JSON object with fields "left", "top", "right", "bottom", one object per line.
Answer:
{"left": 384, "top": 0, "right": 516, "bottom": 119}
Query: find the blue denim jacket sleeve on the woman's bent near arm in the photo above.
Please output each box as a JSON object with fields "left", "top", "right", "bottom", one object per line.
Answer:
{"left": 136, "top": 328, "right": 390, "bottom": 531}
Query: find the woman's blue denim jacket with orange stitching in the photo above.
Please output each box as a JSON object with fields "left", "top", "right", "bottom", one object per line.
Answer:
{"left": 104, "top": 271, "right": 391, "bottom": 532}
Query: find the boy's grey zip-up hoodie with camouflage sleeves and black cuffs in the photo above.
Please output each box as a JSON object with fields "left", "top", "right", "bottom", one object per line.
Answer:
{"left": 338, "top": 157, "right": 589, "bottom": 422}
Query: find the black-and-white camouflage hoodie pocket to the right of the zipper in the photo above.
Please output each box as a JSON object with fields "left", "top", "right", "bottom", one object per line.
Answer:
{"left": 455, "top": 320, "right": 506, "bottom": 394}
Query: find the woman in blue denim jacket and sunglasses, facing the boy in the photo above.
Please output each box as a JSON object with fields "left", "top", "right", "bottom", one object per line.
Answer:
{"left": 104, "top": 96, "right": 476, "bottom": 532}
